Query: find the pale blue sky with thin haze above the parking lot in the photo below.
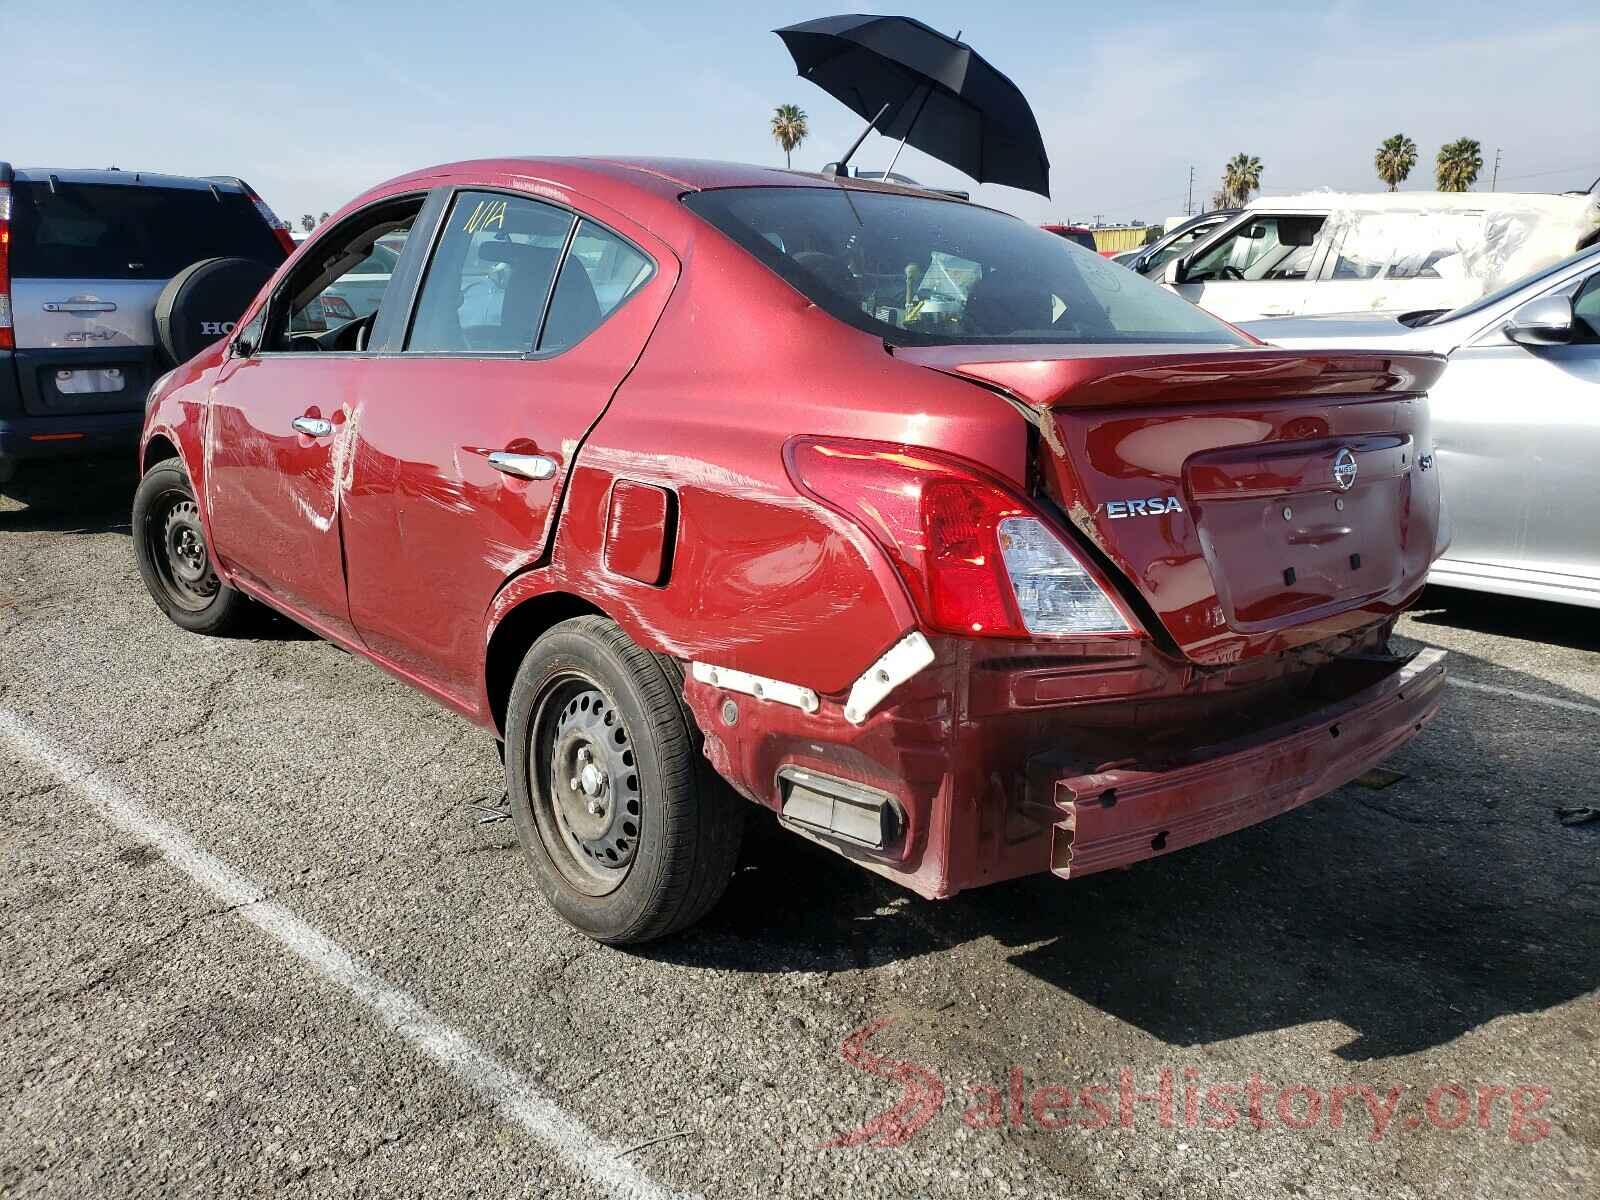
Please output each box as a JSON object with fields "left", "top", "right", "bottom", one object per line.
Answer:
{"left": 0, "top": 0, "right": 1600, "bottom": 219}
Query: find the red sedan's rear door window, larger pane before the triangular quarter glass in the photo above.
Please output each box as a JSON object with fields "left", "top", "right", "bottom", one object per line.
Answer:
{"left": 406, "top": 192, "right": 573, "bottom": 354}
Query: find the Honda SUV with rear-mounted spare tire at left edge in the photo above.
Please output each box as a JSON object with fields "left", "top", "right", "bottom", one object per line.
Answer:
{"left": 0, "top": 162, "right": 294, "bottom": 483}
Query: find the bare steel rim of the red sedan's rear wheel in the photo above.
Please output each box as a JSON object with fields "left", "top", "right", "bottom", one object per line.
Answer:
{"left": 528, "top": 672, "right": 643, "bottom": 896}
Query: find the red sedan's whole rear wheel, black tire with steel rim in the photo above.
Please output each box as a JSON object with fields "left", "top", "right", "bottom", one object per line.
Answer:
{"left": 506, "top": 616, "right": 746, "bottom": 946}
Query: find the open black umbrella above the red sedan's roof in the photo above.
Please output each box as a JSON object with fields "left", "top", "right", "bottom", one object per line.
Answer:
{"left": 773, "top": 14, "right": 1050, "bottom": 197}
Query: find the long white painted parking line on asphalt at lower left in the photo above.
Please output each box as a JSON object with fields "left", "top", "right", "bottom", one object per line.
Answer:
{"left": 0, "top": 709, "right": 688, "bottom": 1200}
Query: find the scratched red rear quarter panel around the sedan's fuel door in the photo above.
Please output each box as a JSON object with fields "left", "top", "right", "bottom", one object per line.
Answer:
{"left": 490, "top": 216, "right": 1027, "bottom": 701}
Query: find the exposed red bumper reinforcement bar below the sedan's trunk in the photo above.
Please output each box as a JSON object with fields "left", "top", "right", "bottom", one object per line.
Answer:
{"left": 1030, "top": 650, "right": 1445, "bottom": 878}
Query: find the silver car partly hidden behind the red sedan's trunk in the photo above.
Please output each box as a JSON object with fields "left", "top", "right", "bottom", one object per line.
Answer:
{"left": 1243, "top": 246, "right": 1600, "bottom": 608}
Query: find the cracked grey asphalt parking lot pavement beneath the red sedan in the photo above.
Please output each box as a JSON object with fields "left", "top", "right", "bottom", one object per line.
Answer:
{"left": 0, "top": 470, "right": 1600, "bottom": 1200}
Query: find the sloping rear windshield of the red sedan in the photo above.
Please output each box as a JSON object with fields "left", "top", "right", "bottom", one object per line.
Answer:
{"left": 683, "top": 187, "right": 1242, "bottom": 346}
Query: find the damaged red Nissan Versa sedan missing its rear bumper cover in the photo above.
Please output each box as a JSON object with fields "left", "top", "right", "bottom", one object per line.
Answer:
{"left": 133, "top": 158, "right": 1445, "bottom": 942}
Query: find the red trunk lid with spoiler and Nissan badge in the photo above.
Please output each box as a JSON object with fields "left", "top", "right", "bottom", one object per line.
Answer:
{"left": 896, "top": 346, "right": 1443, "bottom": 662}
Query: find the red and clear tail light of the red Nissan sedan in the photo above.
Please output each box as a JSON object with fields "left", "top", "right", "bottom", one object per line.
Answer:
{"left": 784, "top": 437, "right": 1134, "bottom": 637}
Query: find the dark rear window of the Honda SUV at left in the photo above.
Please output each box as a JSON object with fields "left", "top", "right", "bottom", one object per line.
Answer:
{"left": 11, "top": 182, "right": 283, "bottom": 278}
